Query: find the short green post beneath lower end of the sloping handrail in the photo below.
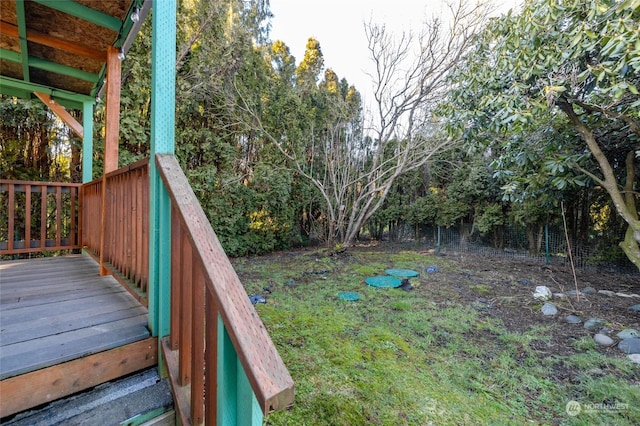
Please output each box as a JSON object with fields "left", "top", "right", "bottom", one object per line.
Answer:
{"left": 216, "top": 316, "right": 263, "bottom": 426}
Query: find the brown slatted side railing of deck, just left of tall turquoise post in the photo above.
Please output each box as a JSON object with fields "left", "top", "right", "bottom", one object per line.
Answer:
{"left": 82, "top": 159, "right": 149, "bottom": 305}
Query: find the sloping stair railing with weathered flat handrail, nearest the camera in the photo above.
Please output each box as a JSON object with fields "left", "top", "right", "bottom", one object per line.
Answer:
{"left": 156, "top": 155, "right": 293, "bottom": 425}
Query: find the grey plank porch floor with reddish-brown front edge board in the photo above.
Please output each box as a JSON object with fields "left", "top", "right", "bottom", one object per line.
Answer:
{"left": 0, "top": 255, "right": 157, "bottom": 417}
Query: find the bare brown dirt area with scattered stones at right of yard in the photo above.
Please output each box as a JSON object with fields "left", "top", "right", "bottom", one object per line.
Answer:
{"left": 420, "top": 248, "right": 640, "bottom": 344}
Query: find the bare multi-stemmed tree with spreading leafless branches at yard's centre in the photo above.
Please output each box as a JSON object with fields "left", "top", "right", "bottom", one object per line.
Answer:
{"left": 235, "top": 0, "right": 489, "bottom": 247}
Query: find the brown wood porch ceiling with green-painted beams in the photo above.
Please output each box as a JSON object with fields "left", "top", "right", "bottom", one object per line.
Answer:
{"left": 0, "top": 0, "right": 146, "bottom": 108}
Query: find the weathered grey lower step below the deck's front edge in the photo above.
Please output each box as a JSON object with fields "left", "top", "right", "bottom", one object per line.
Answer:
{"left": 2, "top": 368, "right": 174, "bottom": 426}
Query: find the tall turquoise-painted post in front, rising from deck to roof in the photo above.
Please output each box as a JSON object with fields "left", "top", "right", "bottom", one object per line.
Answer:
{"left": 148, "top": 0, "right": 176, "bottom": 337}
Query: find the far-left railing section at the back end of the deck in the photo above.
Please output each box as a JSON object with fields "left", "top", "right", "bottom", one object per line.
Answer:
{"left": 0, "top": 179, "right": 81, "bottom": 255}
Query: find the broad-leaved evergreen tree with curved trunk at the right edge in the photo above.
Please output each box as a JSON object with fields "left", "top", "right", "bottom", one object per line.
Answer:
{"left": 443, "top": 0, "right": 640, "bottom": 267}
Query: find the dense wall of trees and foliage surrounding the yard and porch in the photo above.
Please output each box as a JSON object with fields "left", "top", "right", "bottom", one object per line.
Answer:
{"left": 0, "top": 0, "right": 640, "bottom": 268}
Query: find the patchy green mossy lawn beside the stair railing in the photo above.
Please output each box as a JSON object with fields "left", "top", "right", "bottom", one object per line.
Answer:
{"left": 234, "top": 250, "right": 640, "bottom": 426}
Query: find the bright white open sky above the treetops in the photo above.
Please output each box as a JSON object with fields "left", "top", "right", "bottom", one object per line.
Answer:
{"left": 270, "top": 0, "right": 517, "bottom": 106}
